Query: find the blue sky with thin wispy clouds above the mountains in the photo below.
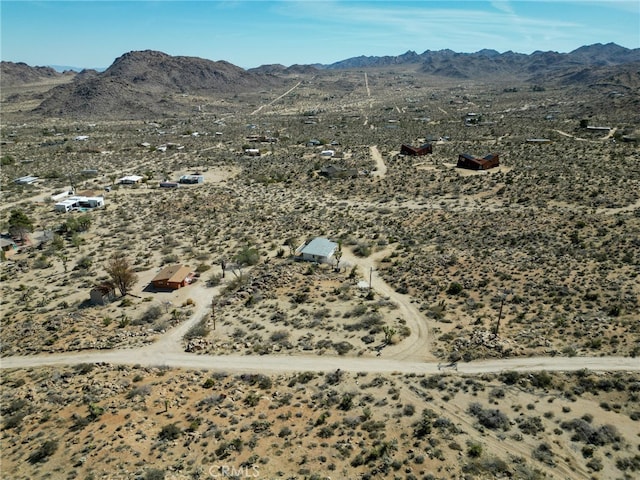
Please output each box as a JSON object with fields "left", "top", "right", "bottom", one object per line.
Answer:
{"left": 0, "top": 0, "right": 640, "bottom": 68}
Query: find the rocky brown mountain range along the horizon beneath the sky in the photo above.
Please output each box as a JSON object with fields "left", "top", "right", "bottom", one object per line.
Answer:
{"left": 0, "top": 43, "right": 640, "bottom": 117}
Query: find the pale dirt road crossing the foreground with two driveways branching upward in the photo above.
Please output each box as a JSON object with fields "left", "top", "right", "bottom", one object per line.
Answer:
{"left": 0, "top": 249, "right": 640, "bottom": 375}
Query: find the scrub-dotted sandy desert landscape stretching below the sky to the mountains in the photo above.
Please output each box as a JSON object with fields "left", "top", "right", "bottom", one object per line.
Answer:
{"left": 0, "top": 44, "right": 640, "bottom": 480}
